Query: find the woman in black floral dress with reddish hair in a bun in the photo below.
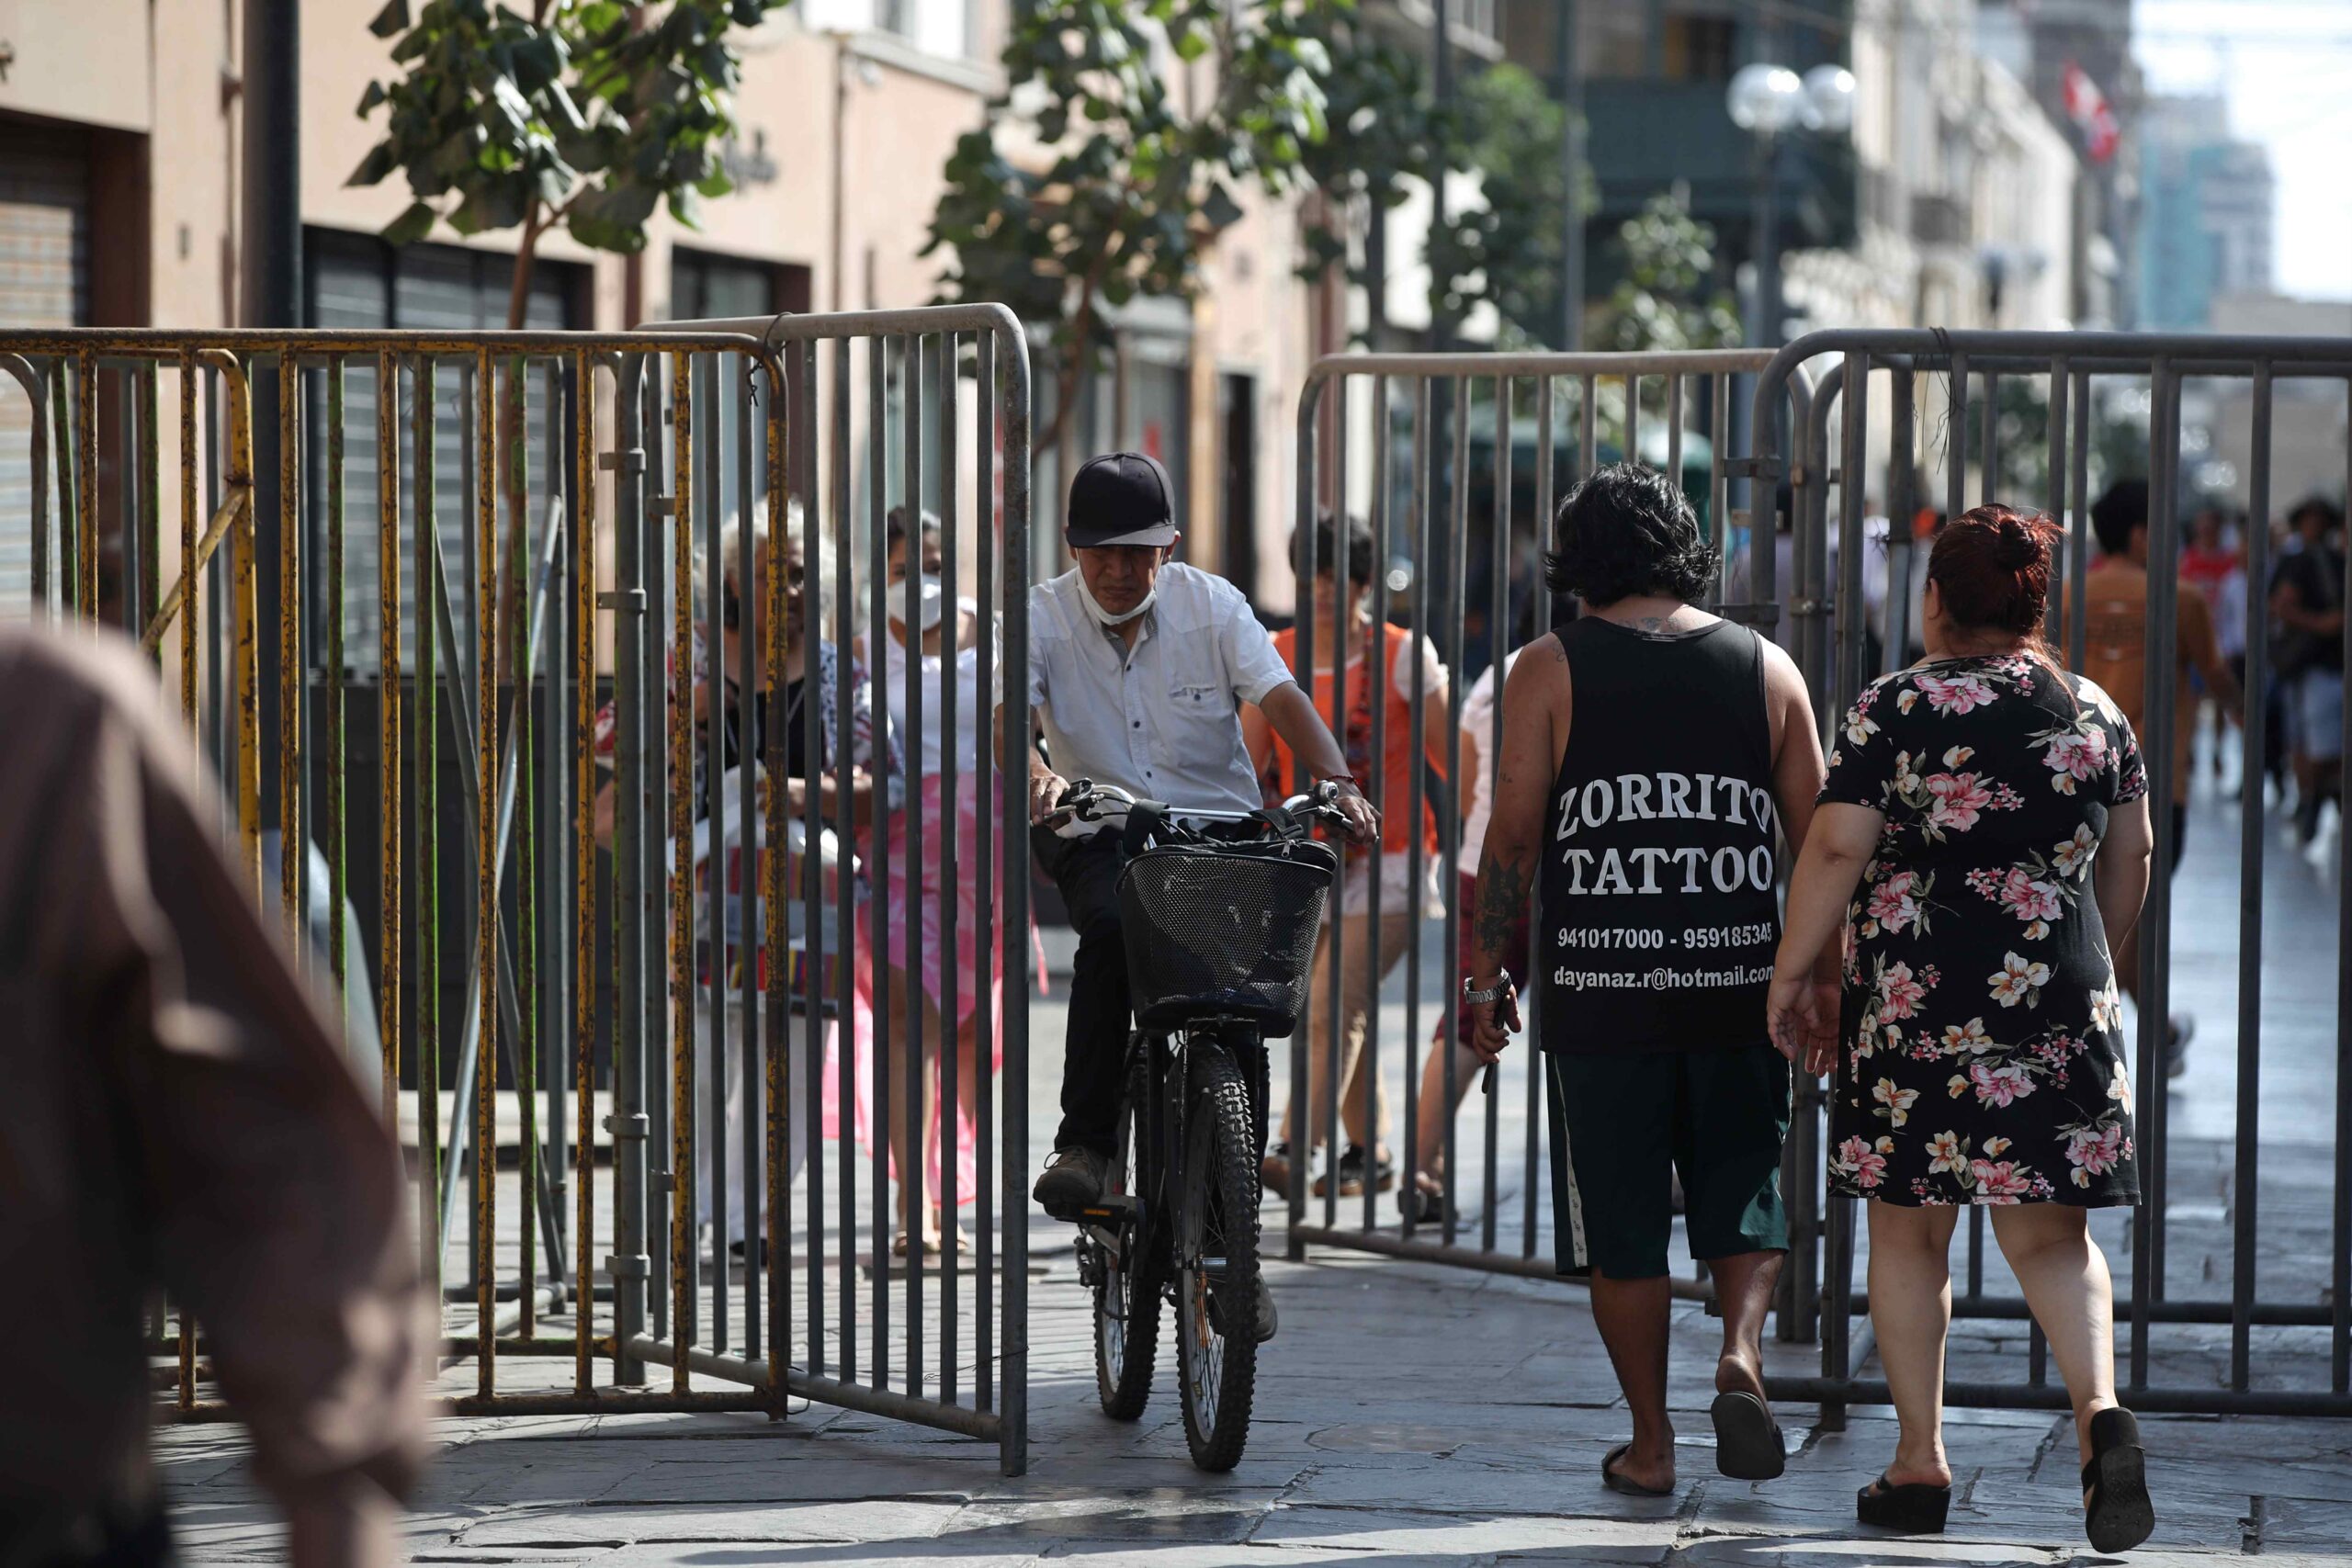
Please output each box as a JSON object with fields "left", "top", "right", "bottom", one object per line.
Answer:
{"left": 1769, "top": 505, "right": 2152, "bottom": 1551}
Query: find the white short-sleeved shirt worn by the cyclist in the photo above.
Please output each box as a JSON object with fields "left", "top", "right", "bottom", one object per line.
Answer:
{"left": 1030, "top": 562, "right": 1291, "bottom": 811}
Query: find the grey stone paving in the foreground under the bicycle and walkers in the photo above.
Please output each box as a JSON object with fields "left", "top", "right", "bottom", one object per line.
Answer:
{"left": 160, "top": 1256, "right": 2352, "bottom": 1568}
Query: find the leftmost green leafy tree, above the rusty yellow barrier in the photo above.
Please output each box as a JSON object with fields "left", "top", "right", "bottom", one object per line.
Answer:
{"left": 350, "top": 0, "right": 790, "bottom": 327}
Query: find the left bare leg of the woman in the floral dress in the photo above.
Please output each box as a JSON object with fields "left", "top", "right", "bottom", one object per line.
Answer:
{"left": 1868, "top": 1201, "right": 1959, "bottom": 1485}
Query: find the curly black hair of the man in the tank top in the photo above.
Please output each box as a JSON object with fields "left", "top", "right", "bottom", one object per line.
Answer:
{"left": 1543, "top": 463, "right": 1722, "bottom": 606}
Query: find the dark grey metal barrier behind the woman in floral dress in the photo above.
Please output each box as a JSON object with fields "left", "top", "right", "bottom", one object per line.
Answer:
{"left": 1743, "top": 332, "right": 2352, "bottom": 1422}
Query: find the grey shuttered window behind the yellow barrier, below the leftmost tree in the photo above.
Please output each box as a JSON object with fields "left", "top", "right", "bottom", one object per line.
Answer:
{"left": 303, "top": 228, "right": 588, "bottom": 674}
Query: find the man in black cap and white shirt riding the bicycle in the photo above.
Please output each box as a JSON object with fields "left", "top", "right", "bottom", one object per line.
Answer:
{"left": 1028, "top": 451, "right": 1381, "bottom": 1215}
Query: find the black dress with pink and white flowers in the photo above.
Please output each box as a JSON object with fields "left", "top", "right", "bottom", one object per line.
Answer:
{"left": 1820, "top": 653, "right": 2147, "bottom": 1208}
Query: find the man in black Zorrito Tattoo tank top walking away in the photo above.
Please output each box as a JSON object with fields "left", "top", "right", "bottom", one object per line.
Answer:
{"left": 1465, "top": 463, "right": 1837, "bottom": 1495}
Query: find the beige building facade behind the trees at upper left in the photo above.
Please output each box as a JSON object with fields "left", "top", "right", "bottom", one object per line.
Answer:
{"left": 0, "top": 0, "right": 1327, "bottom": 609}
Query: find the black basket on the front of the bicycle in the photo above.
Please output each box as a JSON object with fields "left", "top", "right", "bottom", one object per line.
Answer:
{"left": 1120, "top": 844, "right": 1339, "bottom": 1039}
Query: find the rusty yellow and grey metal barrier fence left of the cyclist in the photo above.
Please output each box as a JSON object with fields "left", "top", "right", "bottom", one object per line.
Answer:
{"left": 0, "top": 308, "right": 1028, "bottom": 1472}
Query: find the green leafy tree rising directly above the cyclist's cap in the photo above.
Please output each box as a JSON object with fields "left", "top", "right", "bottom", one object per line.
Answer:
{"left": 924, "top": 0, "right": 1352, "bottom": 446}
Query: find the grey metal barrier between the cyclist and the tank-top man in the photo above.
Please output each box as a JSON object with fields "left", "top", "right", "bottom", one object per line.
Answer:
{"left": 1286, "top": 350, "right": 1820, "bottom": 1297}
